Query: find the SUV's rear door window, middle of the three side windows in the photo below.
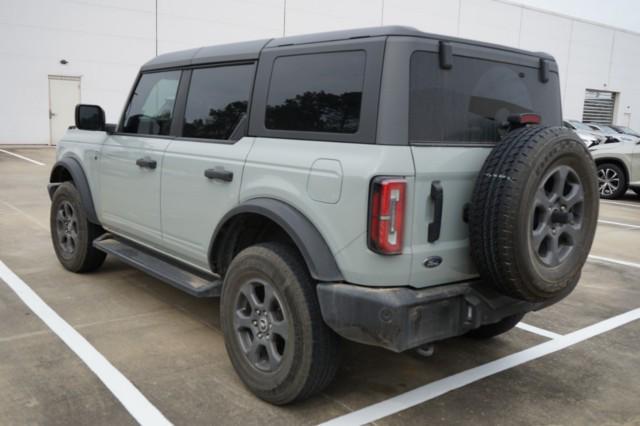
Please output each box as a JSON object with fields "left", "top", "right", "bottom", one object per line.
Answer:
{"left": 182, "top": 64, "right": 254, "bottom": 140}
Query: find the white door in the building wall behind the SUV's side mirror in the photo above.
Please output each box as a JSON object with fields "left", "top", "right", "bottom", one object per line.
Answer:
{"left": 49, "top": 75, "right": 80, "bottom": 145}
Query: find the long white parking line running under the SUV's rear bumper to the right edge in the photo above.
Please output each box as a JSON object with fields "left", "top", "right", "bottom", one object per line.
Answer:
{"left": 322, "top": 308, "right": 640, "bottom": 426}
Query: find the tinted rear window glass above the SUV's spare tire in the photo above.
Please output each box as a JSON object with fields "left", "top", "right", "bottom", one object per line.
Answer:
{"left": 409, "top": 52, "right": 562, "bottom": 143}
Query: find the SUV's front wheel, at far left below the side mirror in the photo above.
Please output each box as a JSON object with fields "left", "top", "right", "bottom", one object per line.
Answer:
{"left": 49, "top": 182, "right": 107, "bottom": 272}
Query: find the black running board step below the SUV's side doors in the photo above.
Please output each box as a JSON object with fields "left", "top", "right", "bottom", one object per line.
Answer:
{"left": 93, "top": 234, "right": 222, "bottom": 297}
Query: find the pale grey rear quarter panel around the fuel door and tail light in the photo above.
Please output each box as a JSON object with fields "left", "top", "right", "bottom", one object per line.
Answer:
{"left": 240, "top": 138, "right": 413, "bottom": 286}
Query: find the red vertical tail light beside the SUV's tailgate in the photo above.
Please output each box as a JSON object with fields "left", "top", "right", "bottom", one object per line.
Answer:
{"left": 369, "top": 177, "right": 407, "bottom": 254}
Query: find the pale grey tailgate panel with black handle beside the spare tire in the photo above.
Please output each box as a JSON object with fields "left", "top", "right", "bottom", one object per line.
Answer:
{"left": 410, "top": 146, "right": 491, "bottom": 287}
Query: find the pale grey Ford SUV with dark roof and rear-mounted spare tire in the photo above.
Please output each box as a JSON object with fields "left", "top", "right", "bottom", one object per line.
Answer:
{"left": 48, "top": 27, "right": 598, "bottom": 404}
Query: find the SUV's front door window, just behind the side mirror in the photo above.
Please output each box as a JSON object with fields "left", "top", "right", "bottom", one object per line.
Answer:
{"left": 123, "top": 71, "right": 180, "bottom": 136}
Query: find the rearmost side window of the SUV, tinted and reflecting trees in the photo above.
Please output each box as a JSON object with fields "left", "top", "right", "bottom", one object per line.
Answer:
{"left": 265, "top": 51, "right": 366, "bottom": 133}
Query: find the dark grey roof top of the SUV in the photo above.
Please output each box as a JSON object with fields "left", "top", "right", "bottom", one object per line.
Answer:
{"left": 142, "top": 26, "right": 553, "bottom": 71}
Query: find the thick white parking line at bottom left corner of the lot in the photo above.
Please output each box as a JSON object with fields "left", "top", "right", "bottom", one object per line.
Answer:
{"left": 0, "top": 260, "right": 171, "bottom": 426}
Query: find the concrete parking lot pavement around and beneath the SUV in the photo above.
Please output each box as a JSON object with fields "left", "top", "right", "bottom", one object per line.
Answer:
{"left": 0, "top": 148, "right": 640, "bottom": 425}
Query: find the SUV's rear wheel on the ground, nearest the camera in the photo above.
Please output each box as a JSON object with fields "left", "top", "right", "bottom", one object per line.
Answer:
{"left": 220, "top": 243, "right": 339, "bottom": 405}
